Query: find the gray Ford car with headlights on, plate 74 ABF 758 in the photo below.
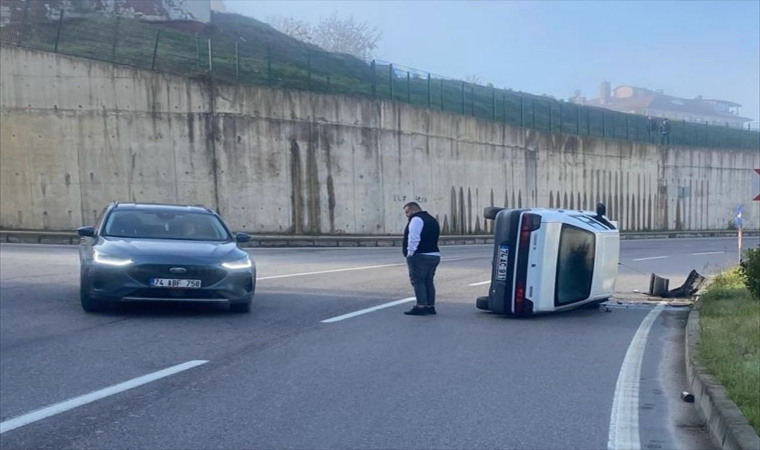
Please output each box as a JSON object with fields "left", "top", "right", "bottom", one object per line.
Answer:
{"left": 77, "top": 203, "right": 256, "bottom": 312}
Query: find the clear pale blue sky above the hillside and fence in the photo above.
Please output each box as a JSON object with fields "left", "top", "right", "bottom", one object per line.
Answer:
{"left": 224, "top": 0, "right": 760, "bottom": 126}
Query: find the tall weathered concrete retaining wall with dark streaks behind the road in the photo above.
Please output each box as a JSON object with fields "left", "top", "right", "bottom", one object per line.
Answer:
{"left": 0, "top": 47, "right": 760, "bottom": 234}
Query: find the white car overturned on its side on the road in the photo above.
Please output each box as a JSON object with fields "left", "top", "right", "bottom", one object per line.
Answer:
{"left": 476, "top": 203, "right": 620, "bottom": 315}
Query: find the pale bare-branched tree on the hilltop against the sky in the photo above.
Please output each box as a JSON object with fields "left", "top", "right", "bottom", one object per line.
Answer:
{"left": 267, "top": 12, "right": 382, "bottom": 59}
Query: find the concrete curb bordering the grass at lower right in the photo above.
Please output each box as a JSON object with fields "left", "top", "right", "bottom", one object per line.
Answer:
{"left": 686, "top": 309, "right": 760, "bottom": 450}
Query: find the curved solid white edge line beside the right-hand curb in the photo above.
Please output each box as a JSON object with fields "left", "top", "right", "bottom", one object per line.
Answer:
{"left": 607, "top": 304, "right": 665, "bottom": 450}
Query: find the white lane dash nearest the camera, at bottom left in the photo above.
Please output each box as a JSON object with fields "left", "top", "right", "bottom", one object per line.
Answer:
{"left": 0, "top": 360, "right": 208, "bottom": 434}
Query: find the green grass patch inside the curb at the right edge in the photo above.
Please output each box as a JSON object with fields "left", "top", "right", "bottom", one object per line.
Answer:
{"left": 698, "top": 269, "right": 760, "bottom": 434}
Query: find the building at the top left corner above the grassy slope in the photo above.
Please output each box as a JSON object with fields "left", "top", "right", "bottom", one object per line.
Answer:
{"left": 0, "top": 0, "right": 211, "bottom": 31}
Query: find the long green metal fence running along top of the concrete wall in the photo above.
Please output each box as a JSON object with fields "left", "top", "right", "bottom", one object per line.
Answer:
{"left": 0, "top": 12, "right": 760, "bottom": 149}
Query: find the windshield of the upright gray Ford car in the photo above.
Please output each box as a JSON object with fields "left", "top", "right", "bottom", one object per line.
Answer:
{"left": 102, "top": 210, "right": 231, "bottom": 241}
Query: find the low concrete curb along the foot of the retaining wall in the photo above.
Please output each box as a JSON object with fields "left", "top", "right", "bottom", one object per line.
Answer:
{"left": 0, "top": 230, "right": 760, "bottom": 247}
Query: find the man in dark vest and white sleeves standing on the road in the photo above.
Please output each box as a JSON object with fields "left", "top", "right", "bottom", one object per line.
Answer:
{"left": 403, "top": 202, "right": 441, "bottom": 316}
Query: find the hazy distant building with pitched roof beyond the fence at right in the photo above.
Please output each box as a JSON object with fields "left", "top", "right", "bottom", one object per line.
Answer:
{"left": 570, "top": 81, "right": 752, "bottom": 128}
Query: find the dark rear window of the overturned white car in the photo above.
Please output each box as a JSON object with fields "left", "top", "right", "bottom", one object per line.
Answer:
{"left": 554, "top": 224, "right": 595, "bottom": 305}
